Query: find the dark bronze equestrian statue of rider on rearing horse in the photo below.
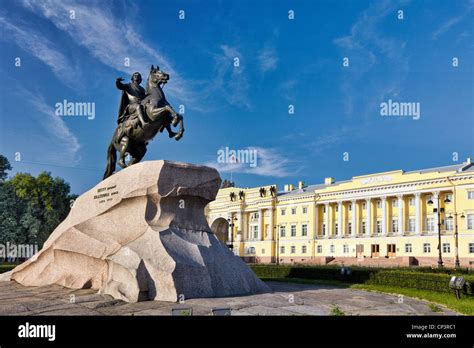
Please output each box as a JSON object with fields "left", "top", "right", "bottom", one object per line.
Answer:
{"left": 104, "top": 65, "right": 184, "bottom": 179}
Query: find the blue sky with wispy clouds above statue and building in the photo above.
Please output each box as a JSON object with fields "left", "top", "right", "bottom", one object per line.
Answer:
{"left": 0, "top": 0, "right": 474, "bottom": 194}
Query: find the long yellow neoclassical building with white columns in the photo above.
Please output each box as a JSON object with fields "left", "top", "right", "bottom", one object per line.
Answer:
{"left": 206, "top": 158, "right": 474, "bottom": 267}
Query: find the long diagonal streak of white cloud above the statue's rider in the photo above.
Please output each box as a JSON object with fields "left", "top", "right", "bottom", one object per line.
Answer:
{"left": 23, "top": 0, "right": 194, "bottom": 103}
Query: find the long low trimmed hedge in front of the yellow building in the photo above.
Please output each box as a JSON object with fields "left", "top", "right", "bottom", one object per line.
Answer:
{"left": 251, "top": 265, "right": 474, "bottom": 295}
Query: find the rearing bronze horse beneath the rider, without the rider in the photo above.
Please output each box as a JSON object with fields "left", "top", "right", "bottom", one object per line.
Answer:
{"left": 104, "top": 65, "right": 184, "bottom": 179}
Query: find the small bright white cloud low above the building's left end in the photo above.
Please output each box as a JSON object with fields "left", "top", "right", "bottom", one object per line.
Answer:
{"left": 206, "top": 147, "right": 299, "bottom": 177}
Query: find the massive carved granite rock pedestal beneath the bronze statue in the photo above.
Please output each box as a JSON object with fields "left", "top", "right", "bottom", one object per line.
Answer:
{"left": 0, "top": 161, "right": 270, "bottom": 302}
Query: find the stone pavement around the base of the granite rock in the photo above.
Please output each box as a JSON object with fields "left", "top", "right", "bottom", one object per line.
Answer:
{"left": 0, "top": 282, "right": 458, "bottom": 315}
